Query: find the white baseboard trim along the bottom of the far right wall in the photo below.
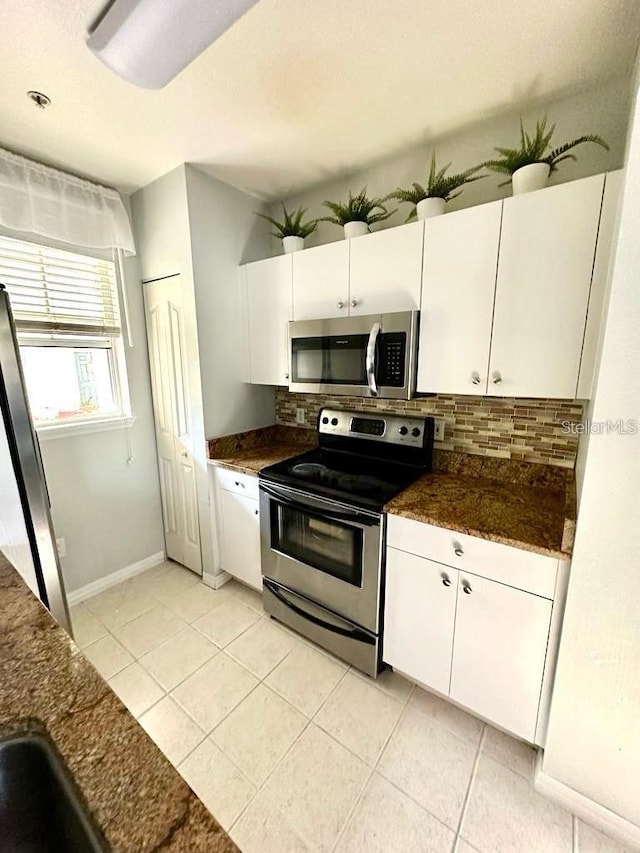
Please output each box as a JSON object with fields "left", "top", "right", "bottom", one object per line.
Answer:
{"left": 533, "top": 751, "right": 640, "bottom": 851}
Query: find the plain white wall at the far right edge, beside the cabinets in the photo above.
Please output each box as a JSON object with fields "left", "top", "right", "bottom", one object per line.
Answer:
{"left": 543, "top": 66, "right": 640, "bottom": 826}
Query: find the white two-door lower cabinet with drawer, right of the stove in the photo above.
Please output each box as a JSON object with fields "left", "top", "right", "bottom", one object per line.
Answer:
{"left": 383, "top": 515, "right": 568, "bottom": 745}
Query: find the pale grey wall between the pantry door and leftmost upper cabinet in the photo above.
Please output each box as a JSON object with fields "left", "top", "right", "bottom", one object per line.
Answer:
{"left": 186, "top": 165, "right": 275, "bottom": 438}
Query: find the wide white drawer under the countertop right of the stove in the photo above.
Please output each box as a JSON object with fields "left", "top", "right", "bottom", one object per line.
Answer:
{"left": 387, "top": 515, "right": 558, "bottom": 599}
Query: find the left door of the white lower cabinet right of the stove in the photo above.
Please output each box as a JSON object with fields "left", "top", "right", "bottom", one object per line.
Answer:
{"left": 382, "top": 548, "right": 458, "bottom": 695}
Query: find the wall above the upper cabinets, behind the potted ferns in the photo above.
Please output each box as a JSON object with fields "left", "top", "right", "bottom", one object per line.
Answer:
{"left": 264, "top": 77, "right": 630, "bottom": 254}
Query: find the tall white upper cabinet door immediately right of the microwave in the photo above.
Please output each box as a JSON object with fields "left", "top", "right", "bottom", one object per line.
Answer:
{"left": 418, "top": 201, "right": 502, "bottom": 394}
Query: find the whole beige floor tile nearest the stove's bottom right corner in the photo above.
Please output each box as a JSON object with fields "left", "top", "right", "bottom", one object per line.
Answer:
{"left": 314, "top": 672, "right": 404, "bottom": 764}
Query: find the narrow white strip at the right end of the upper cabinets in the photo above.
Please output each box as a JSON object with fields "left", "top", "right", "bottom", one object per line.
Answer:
{"left": 577, "top": 170, "right": 623, "bottom": 400}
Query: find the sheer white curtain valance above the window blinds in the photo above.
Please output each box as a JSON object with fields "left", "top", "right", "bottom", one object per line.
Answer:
{"left": 0, "top": 148, "right": 136, "bottom": 255}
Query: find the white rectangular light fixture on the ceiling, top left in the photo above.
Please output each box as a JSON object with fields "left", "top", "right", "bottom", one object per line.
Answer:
{"left": 87, "top": 0, "right": 257, "bottom": 89}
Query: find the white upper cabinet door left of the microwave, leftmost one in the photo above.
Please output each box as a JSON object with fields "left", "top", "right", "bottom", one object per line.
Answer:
{"left": 245, "top": 255, "right": 292, "bottom": 385}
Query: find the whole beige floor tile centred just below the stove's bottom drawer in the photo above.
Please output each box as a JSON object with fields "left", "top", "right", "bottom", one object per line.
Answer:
{"left": 265, "top": 643, "right": 347, "bottom": 717}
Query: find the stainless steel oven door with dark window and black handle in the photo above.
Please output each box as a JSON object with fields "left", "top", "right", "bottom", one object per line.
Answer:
{"left": 260, "top": 481, "right": 382, "bottom": 633}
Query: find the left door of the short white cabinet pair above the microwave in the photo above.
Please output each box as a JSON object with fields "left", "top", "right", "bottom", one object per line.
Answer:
{"left": 293, "top": 240, "right": 349, "bottom": 320}
